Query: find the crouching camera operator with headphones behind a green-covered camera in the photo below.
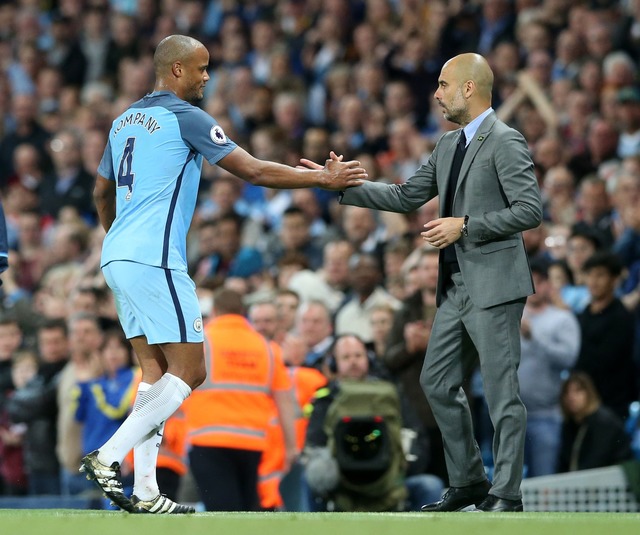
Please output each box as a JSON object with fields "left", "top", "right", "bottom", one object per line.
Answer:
{"left": 304, "top": 334, "right": 443, "bottom": 511}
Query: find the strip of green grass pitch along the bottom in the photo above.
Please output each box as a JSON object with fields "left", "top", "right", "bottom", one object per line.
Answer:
{"left": 0, "top": 509, "right": 640, "bottom": 535}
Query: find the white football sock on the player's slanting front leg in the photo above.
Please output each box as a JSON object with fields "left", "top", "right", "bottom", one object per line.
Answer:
{"left": 98, "top": 373, "right": 191, "bottom": 466}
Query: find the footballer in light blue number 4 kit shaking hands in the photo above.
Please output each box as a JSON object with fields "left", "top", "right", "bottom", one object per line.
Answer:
{"left": 87, "top": 35, "right": 367, "bottom": 514}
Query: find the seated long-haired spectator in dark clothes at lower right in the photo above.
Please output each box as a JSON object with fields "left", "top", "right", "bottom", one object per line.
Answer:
{"left": 557, "top": 372, "right": 633, "bottom": 472}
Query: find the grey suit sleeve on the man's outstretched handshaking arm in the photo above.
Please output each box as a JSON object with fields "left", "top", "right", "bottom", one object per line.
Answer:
{"left": 340, "top": 148, "right": 438, "bottom": 214}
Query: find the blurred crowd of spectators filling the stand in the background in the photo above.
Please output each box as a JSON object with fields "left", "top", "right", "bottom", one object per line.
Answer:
{"left": 0, "top": 0, "right": 640, "bottom": 510}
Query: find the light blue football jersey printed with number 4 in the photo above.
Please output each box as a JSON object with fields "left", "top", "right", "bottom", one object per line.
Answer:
{"left": 98, "top": 91, "right": 237, "bottom": 271}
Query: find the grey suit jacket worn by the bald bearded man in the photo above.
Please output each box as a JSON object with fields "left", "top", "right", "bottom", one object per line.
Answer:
{"left": 340, "top": 112, "right": 542, "bottom": 308}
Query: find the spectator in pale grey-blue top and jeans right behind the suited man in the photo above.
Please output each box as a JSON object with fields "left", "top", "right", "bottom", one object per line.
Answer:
{"left": 518, "top": 261, "right": 580, "bottom": 477}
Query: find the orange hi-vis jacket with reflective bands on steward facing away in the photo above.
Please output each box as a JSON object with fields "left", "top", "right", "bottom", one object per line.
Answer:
{"left": 183, "top": 314, "right": 291, "bottom": 451}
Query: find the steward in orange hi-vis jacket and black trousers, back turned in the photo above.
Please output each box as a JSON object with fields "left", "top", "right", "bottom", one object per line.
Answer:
{"left": 183, "top": 289, "right": 295, "bottom": 511}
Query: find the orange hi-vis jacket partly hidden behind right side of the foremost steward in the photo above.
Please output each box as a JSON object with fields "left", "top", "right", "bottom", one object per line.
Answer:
{"left": 258, "top": 362, "right": 327, "bottom": 509}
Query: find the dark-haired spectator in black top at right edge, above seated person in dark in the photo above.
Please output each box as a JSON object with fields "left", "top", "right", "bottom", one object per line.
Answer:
{"left": 575, "top": 251, "right": 638, "bottom": 419}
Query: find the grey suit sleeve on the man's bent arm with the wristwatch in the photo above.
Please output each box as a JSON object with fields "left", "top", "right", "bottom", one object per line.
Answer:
{"left": 468, "top": 128, "right": 542, "bottom": 242}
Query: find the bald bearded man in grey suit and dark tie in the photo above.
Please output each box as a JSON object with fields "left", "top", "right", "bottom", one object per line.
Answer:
{"left": 301, "top": 54, "right": 542, "bottom": 511}
